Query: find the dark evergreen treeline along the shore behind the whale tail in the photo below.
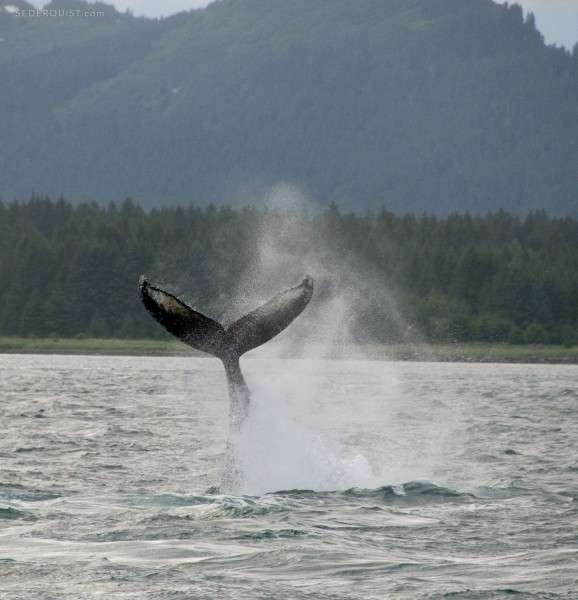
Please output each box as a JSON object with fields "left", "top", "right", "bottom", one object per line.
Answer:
{"left": 0, "top": 198, "right": 578, "bottom": 345}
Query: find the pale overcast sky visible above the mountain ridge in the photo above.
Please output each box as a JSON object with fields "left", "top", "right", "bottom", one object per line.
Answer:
{"left": 32, "top": 0, "right": 578, "bottom": 48}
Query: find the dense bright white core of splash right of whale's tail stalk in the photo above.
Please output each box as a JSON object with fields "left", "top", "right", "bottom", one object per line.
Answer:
{"left": 225, "top": 361, "right": 379, "bottom": 495}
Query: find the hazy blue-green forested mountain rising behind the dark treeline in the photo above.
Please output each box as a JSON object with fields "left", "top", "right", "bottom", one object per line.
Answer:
{"left": 0, "top": 0, "right": 578, "bottom": 216}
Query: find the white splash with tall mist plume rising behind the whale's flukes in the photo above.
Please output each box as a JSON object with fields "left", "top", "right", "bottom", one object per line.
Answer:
{"left": 223, "top": 186, "right": 456, "bottom": 494}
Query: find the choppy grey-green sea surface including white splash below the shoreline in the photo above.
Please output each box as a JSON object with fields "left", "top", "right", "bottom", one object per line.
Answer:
{"left": 0, "top": 355, "right": 578, "bottom": 600}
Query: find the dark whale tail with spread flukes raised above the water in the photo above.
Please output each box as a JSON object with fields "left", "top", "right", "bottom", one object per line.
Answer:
{"left": 139, "top": 275, "right": 313, "bottom": 429}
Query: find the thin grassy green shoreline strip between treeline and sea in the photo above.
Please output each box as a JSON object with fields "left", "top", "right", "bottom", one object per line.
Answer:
{"left": 0, "top": 337, "right": 578, "bottom": 365}
